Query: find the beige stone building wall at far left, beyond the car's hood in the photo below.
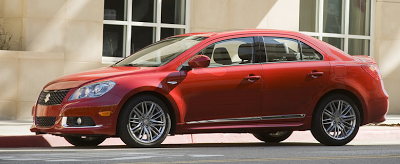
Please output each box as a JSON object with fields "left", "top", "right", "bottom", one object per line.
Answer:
{"left": 0, "top": 0, "right": 104, "bottom": 119}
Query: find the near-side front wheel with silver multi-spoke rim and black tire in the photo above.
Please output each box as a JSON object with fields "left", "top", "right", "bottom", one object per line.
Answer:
{"left": 117, "top": 95, "right": 171, "bottom": 147}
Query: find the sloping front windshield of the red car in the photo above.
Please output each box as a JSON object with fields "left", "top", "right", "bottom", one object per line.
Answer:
{"left": 114, "top": 36, "right": 206, "bottom": 67}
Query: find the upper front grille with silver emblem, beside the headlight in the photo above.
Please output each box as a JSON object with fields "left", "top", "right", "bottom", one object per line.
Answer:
{"left": 38, "top": 89, "right": 69, "bottom": 106}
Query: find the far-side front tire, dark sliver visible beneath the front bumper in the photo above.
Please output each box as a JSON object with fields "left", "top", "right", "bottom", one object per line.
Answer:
{"left": 64, "top": 136, "right": 107, "bottom": 146}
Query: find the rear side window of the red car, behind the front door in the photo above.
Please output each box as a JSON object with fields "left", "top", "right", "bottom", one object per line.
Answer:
{"left": 263, "top": 37, "right": 322, "bottom": 62}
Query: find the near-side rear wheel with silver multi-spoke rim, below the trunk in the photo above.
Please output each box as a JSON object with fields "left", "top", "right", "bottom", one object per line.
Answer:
{"left": 311, "top": 94, "right": 361, "bottom": 146}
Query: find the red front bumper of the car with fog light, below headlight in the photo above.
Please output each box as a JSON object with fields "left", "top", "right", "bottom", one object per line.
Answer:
{"left": 30, "top": 94, "right": 121, "bottom": 136}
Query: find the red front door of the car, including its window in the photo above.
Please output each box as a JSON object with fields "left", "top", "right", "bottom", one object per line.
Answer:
{"left": 180, "top": 37, "right": 262, "bottom": 123}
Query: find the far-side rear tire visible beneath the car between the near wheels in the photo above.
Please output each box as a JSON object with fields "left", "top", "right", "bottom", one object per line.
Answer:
{"left": 253, "top": 131, "right": 293, "bottom": 143}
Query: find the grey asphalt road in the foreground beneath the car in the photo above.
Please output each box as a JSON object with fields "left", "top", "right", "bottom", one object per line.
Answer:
{"left": 0, "top": 142, "right": 400, "bottom": 164}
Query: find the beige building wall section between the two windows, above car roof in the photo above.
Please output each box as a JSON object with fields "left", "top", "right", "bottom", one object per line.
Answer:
{"left": 190, "top": 0, "right": 300, "bottom": 32}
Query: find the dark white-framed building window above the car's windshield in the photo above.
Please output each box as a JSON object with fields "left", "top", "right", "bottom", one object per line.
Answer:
{"left": 103, "top": 0, "right": 189, "bottom": 63}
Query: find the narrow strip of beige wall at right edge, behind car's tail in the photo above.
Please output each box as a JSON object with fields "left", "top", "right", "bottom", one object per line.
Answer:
{"left": 374, "top": 0, "right": 400, "bottom": 114}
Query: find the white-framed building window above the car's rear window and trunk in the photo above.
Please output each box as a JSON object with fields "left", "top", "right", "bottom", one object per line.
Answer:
{"left": 299, "top": 0, "right": 375, "bottom": 56}
